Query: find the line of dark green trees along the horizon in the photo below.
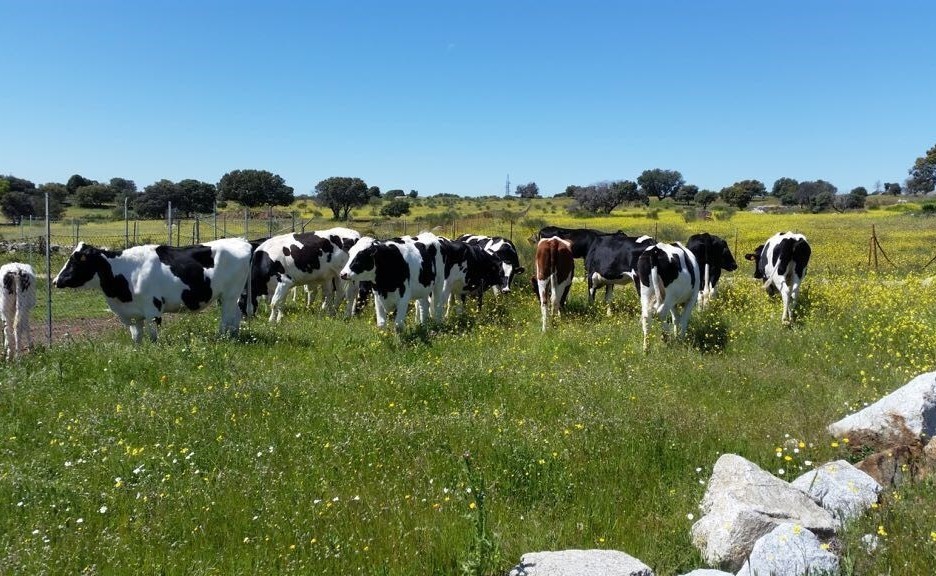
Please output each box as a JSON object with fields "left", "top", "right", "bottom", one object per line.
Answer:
{"left": 0, "top": 145, "right": 936, "bottom": 224}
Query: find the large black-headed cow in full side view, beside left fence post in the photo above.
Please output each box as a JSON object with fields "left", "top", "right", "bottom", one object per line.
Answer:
{"left": 52, "top": 238, "right": 250, "bottom": 344}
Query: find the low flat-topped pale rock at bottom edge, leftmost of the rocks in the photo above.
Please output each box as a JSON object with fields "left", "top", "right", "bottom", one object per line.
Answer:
{"left": 510, "top": 550, "right": 653, "bottom": 576}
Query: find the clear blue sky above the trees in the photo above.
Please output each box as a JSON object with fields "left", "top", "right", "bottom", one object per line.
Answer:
{"left": 0, "top": 0, "right": 936, "bottom": 196}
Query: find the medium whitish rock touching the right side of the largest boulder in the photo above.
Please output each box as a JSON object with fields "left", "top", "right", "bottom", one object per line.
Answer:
{"left": 791, "top": 460, "right": 882, "bottom": 525}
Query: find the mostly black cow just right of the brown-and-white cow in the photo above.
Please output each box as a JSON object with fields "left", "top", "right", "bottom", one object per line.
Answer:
{"left": 585, "top": 232, "right": 654, "bottom": 316}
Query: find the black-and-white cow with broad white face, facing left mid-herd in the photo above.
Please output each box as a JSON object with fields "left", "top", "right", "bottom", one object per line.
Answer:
{"left": 340, "top": 232, "right": 445, "bottom": 330}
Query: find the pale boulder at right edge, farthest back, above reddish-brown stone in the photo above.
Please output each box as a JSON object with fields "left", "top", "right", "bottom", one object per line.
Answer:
{"left": 828, "top": 372, "right": 936, "bottom": 449}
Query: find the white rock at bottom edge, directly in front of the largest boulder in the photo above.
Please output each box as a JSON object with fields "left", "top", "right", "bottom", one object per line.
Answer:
{"left": 737, "top": 524, "right": 839, "bottom": 576}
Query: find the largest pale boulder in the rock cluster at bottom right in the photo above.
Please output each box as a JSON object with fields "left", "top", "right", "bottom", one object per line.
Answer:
{"left": 692, "top": 454, "right": 836, "bottom": 570}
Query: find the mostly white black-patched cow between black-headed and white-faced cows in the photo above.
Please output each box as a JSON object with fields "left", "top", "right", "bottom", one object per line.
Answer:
{"left": 240, "top": 232, "right": 350, "bottom": 322}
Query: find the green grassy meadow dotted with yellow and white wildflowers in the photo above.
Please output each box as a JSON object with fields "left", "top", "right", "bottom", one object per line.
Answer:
{"left": 0, "top": 200, "right": 936, "bottom": 576}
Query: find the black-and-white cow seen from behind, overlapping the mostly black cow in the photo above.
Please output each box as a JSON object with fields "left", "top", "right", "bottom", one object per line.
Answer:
{"left": 637, "top": 242, "right": 702, "bottom": 352}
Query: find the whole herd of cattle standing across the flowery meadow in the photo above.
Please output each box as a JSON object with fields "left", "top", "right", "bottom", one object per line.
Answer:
{"left": 0, "top": 226, "right": 810, "bottom": 356}
